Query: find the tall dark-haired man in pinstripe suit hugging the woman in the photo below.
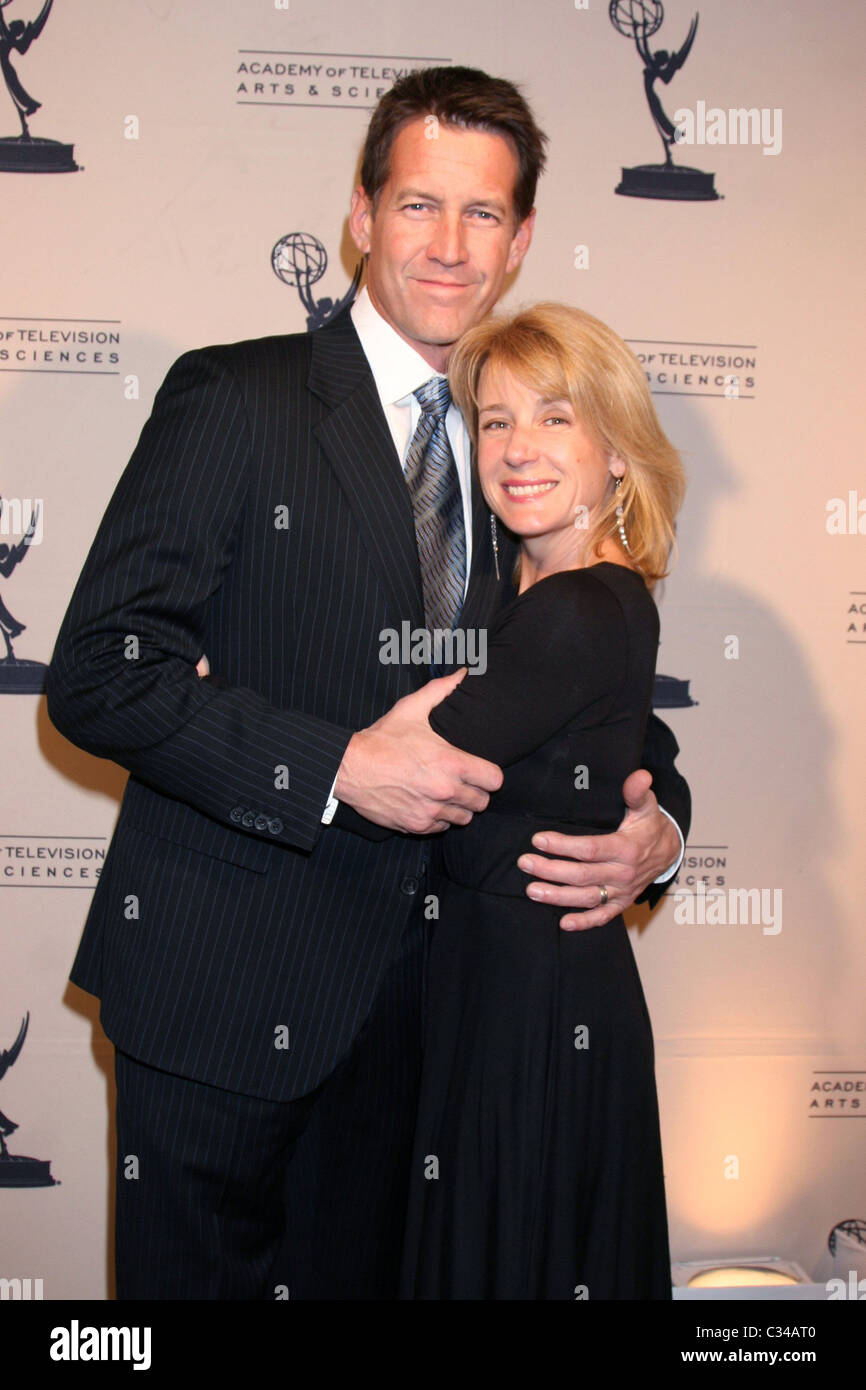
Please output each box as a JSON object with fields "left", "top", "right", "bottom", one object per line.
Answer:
{"left": 47, "top": 68, "right": 688, "bottom": 1298}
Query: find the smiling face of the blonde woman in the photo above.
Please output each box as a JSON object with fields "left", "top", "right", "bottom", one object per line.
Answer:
{"left": 478, "top": 367, "right": 623, "bottom": 556}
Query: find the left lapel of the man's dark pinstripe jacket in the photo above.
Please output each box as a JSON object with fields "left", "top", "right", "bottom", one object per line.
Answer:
{"left": 309, "top": 313, "right": 424, "bottom": 627}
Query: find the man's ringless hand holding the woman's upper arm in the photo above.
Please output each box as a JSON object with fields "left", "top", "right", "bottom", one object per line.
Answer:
{"left": 334, "top": 667, "right": 502, "bottom": 835}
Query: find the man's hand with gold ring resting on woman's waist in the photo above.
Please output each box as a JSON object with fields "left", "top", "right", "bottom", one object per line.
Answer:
{"left": 517, "top": 770, "right": 680, "bottom": 931}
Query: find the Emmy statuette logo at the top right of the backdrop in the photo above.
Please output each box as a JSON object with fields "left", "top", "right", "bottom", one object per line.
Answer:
{"left": 609, "top": 0, "right": 719, "bottom": 203}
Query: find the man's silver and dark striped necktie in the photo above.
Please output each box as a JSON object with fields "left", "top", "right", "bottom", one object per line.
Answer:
{"left": 403, "top": 377, "right": 466, "bottom": 631}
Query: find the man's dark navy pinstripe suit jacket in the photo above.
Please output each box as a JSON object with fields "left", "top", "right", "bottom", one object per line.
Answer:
{"left": 47, "top": 314, "right": 688, "bottom": 1099}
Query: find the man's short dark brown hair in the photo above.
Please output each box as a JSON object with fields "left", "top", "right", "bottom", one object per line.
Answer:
{"left": 361, "top": 67, "right": 548, "bottom": 222}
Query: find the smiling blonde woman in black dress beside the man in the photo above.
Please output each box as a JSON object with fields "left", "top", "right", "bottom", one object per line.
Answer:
{"left": 402, "top": 304, "right": 684, "bottom": 1300}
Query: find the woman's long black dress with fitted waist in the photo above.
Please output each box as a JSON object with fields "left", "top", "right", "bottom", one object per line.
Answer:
{"left": 402, "top": 563, "right": 671, "bottom": 1300}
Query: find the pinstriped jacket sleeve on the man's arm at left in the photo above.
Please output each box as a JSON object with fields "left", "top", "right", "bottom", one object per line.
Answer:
{"left": 46, "top": 341, "right": 353, "bottom": 849}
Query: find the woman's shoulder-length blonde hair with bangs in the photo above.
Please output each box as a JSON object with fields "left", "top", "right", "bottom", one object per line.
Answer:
{"left": 448, "top": 303, "right": 685, "bottom": 588}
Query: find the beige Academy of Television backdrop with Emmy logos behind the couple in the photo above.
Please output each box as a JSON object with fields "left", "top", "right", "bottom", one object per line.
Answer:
{"left": 0, "top": 0, "right": 866, "bottom": 1300}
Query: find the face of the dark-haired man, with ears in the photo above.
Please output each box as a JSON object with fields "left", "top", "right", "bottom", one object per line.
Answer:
{"left": 349, "top": 118, "right": 535, "bottom": 371}
